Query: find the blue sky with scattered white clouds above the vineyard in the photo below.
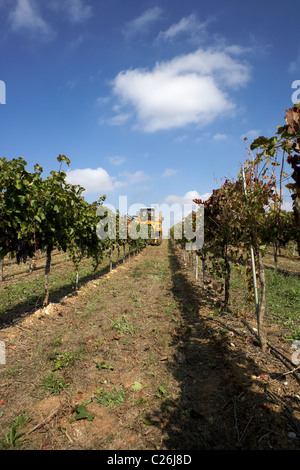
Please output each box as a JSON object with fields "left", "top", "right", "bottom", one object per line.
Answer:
{"left": 0, "top": 0, "right": 300, "bottom": 225}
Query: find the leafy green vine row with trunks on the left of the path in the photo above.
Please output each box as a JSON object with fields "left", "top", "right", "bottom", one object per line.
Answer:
{"left": 0, "top": 155, "right": 148, "bottom": 305}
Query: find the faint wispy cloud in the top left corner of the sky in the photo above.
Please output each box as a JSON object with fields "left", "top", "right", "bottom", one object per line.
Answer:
{"left": 10, "top": 0, "right": 56, "bottom": 40}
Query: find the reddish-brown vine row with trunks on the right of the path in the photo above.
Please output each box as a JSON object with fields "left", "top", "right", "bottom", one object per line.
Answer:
{"left": 171, "top": 103, "right": 300, "bottom": 350}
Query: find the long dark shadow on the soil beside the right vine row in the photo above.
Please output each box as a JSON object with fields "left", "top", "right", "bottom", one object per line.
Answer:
{"left": 145, "top": 241, "right": 299, "bottom": 450}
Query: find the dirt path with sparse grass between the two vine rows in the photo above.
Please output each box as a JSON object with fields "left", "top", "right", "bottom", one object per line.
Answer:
{"left": 0, "top": 241, "right": 300, "bottom": 450}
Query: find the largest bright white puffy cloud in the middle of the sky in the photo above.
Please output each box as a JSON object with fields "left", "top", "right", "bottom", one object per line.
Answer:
{"left": 112, "top": 49, "right": 250, "bottom": 132}
